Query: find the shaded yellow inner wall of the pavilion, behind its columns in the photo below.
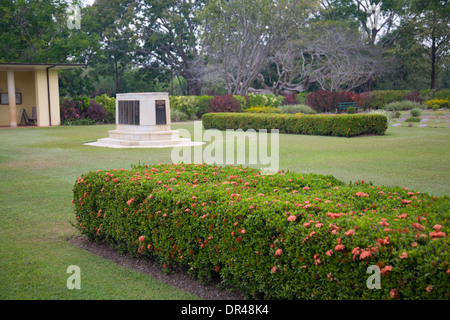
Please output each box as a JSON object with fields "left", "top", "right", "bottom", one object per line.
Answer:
{"left": 0, "top": 71, "right": 36, "bottom": 126}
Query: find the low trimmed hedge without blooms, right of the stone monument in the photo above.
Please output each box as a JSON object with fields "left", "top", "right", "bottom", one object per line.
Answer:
{"left": 202, "top": 113, "right": 388, "bottom": 137}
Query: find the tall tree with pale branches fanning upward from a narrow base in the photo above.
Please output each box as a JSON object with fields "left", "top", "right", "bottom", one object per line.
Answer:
{"left": 203, "top": 0, "right": 315, "bottom": 94}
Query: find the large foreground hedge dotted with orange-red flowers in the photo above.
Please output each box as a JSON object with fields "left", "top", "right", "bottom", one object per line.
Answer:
{"left": 73, "top": 164, "right": 450, "bottom": 299}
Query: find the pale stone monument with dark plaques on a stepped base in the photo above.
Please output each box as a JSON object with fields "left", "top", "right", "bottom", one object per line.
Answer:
{"left": 86, "top": 92, "right": 202, "bottom": 148}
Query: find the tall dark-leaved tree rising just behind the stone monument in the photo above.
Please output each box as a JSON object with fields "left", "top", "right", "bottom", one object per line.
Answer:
{"left": 140, "top": 0, "right": 206, "bottom": 95}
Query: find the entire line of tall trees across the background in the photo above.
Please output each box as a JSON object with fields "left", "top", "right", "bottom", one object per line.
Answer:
{"left": 0, "top": 0, "right": 450, "bottom": 97}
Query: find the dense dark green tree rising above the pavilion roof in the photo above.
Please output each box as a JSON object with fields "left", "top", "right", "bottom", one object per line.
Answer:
{"left": 0, "top": 0, "right": 87, "bottom": 63}
